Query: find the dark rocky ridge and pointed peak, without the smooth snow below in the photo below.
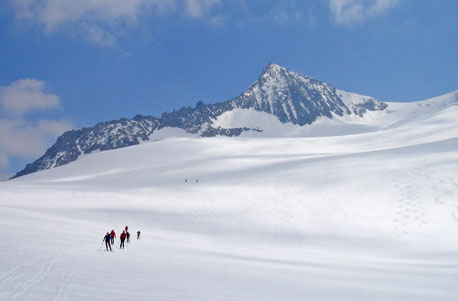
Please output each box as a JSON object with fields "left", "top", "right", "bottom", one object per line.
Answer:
{"left": 14, "top": 63, "right": 387, "bottom": 178}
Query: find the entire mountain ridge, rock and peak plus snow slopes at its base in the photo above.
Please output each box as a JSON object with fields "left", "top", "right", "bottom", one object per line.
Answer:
{"left": 11, "top": 63, "right": 457, "bottom": 177}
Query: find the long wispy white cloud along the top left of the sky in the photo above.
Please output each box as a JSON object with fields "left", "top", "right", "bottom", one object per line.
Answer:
{"left": 9, "top": 0, "right": 224, "bottom": 47}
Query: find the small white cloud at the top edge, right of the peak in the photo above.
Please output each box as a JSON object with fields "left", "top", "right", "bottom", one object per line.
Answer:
{"left": 329, "top": 0, "right": 401, "bottom": 25}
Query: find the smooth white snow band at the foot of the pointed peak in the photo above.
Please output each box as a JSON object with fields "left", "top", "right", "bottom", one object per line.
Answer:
{"left": 212, "top": 90, "right": 458, "bottom": 137}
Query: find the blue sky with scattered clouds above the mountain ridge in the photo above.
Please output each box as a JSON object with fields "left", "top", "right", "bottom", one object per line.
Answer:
{"left": 0, "top": 0, "right": 458, "bottom": 174}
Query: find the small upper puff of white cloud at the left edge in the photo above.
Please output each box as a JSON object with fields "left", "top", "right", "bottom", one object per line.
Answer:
{"left": 0, "top": 79, "right": 60, "bottom": 115}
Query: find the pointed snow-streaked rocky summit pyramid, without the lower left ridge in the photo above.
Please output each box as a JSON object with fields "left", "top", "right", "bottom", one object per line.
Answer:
{"left": 218, "top": 63, "right": 386, "bottom": 126}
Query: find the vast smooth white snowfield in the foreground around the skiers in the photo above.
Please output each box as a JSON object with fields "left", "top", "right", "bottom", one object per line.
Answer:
{"left": 0, "top": 92, "right": 458, "bottom": 300}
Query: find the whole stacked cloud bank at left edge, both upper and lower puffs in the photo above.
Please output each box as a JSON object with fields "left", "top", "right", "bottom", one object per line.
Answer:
{"left": 0, "top": 79, "right": 72, "bottom": 171}
